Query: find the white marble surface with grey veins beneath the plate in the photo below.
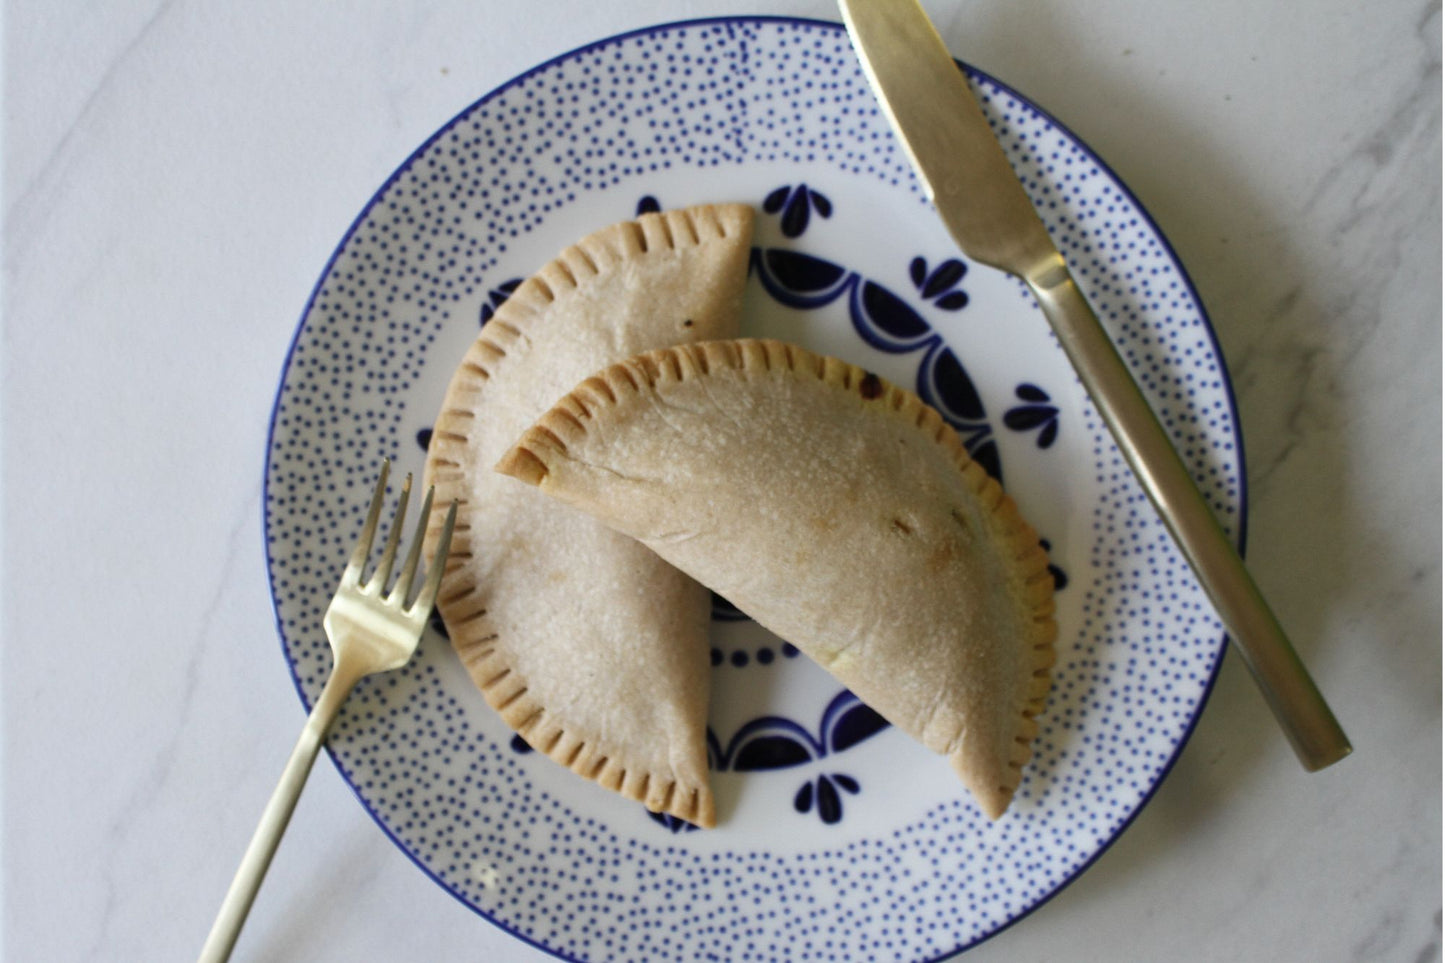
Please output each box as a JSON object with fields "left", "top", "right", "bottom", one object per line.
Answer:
{"left": 0, "top": 0, "right": 1441, "bottom": 962}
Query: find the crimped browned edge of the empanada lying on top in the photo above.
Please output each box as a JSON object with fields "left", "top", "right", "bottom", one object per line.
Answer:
{"left": 496, "top": 338, "right": 1058, "bottom": 818}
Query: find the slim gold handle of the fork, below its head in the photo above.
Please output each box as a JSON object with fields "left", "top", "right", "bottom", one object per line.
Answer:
{"left": 199, "top": 664, "right": 361, "bottom": 963}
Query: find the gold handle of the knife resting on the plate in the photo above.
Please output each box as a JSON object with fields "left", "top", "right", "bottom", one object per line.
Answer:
{"left": 1023, "top": 252, "right": 1351, "bottom": 772}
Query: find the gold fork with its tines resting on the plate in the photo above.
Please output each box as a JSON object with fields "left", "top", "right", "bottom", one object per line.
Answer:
{"left": 201, "top": 461, "right": 457, "bottom": 963}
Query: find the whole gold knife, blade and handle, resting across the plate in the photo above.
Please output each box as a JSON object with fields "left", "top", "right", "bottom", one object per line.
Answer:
{"left": 840, "top": 0, "right": 1351, "bottom": 772}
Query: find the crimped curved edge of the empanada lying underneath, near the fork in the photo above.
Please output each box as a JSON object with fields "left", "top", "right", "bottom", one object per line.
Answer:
{"left": 423, "top": 204, "right": 753, "bottom": 827}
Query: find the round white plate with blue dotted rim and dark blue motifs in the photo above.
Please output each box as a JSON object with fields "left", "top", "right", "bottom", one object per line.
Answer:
{"left": 266, "top": 17, "right": 1244, "bottom": 960}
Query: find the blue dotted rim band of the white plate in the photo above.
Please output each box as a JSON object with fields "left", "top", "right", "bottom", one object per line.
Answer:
{"left": 266, "top": 19, "right": 1243, "bottom": 960}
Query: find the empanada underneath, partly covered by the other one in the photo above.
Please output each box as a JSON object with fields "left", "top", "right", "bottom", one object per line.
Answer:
{"left": 426, "top": 204, "right": 753, "bottom": 826}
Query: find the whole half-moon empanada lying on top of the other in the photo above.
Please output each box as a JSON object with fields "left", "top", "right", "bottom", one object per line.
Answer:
{"left": 497, "top": 340, "right": 1056, "bottom": 818}
